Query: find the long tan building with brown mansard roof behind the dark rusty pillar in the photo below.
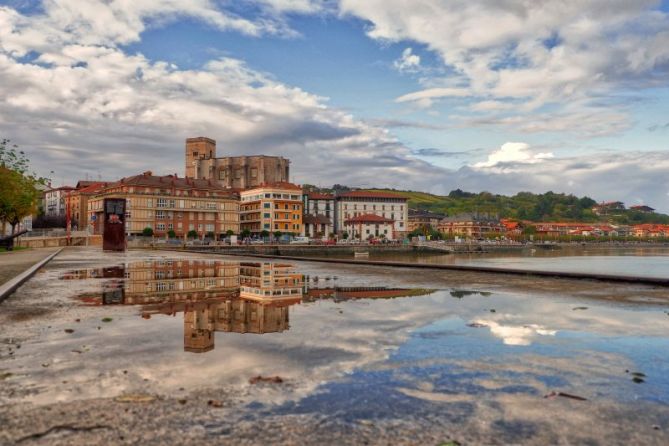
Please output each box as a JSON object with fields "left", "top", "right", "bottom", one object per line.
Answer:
{"left": 88, "top": 172, "right": 240, "bottom": 238}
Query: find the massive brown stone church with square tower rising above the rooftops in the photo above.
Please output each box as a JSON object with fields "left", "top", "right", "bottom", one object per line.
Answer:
{"left": 185, "top": 136, "right": 290, "bottom": 189}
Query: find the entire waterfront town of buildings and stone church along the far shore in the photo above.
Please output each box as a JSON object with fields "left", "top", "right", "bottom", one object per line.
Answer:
{"left": 2, "top": 137, "right": 669, "bottom": 243}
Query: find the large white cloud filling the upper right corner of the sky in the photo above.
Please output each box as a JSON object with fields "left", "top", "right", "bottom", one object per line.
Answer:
{"left": 340, "top": 0, "right": 669, "bottom": 134}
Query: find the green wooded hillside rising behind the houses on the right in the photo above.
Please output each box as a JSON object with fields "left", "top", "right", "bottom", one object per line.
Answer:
{"left": 305, "top": 185, "right": 669, "bottom": 224}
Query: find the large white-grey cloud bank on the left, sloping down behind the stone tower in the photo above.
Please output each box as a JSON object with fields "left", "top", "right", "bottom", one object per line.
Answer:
{"left": 0, "top": 1, "right": 452, "bottom": 191}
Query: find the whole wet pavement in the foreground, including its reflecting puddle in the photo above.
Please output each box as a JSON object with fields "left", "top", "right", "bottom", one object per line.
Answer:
{"left": 0, "top": 249, "right": 669, "bottom": 444}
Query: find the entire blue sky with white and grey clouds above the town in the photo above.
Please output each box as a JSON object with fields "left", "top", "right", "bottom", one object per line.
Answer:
{"left": 0, "top": 0, "right": 669, "bottom": 212}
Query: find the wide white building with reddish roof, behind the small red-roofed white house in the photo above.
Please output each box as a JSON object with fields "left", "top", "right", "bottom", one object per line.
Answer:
{"left": 335, "top": 190, "right": 409, "bottom": 239}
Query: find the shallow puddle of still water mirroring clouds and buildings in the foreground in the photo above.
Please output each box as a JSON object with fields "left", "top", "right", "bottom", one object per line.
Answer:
{"left": 0, "top": 249, "right": 669, "bottom": 444}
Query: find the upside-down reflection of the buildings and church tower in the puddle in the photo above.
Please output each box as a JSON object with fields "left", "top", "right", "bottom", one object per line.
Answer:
{"left": 61, "top": 260, "right": 431, "bottom": 353}
